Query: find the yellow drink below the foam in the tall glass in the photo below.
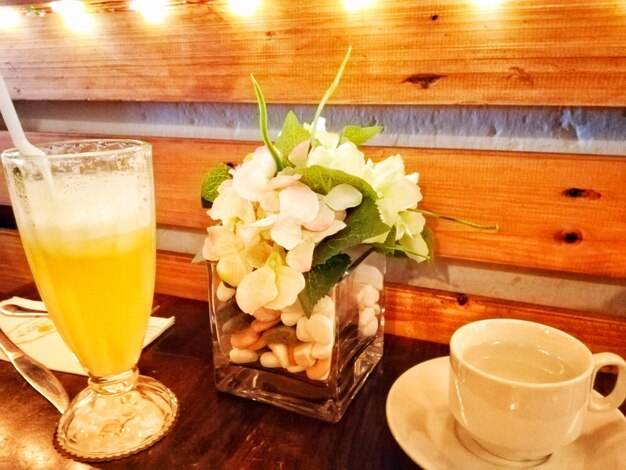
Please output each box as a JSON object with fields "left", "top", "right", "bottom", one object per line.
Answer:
{"left": 23, "top": 227, "right": 155, "bottom": 376}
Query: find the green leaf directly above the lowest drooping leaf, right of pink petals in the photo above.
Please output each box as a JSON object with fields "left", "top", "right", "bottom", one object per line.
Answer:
{"left": 313, "top": 198, "right": 390, "bottom": 265}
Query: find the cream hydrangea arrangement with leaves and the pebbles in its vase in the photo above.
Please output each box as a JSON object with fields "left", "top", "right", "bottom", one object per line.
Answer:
{"left": 202, "top": 51, "right": 492, "bottom": 390}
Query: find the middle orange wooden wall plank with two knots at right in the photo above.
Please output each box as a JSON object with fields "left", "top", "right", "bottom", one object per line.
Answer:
{"left": 0, "top": 132, "right": 626, "bottom": 277}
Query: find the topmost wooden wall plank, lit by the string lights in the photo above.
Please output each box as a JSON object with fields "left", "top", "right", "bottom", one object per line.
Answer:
{"left": 0, "top": 0, "right": 626, "bottom": 106}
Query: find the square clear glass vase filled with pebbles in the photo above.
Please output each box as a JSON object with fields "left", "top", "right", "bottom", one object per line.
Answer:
{"left": 208, "top": 252, "right": 386, "bottom": 423}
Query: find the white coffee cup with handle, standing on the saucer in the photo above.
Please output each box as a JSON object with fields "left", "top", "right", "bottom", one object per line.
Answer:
{"left": 449, "top": 319, "right": 626, "bottom": 464}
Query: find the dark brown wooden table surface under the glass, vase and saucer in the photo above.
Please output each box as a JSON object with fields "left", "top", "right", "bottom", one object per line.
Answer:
{"left": 0, "top": 288, "right": 620, "bottom": 470}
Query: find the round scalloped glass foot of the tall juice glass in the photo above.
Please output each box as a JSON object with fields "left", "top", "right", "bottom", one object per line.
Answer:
{"left": 55, "top": 376, "right": 178, "bottom": 461}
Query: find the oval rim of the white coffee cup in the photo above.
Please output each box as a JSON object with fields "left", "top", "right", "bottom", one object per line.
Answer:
{"left": 450, "top": 318, "right": 594, "bottom": 389}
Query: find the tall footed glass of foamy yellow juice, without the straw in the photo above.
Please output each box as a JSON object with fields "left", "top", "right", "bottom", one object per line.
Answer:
{"left": 2, "top": 140, "right": 178, "bottom": 460}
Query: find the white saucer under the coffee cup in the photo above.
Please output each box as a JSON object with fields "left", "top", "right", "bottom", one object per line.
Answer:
{"left": 387, "top": 356, "right": 626, "bottom": 470}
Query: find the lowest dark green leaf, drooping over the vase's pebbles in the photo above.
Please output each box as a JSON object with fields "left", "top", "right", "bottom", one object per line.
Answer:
{"left": 298, "top": 254, "right": 350, "bottom": 318}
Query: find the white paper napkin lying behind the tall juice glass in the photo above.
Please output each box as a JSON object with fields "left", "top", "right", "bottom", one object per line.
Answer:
{"left": 0, "top": 297, "right": 174, "bottom": 375}
